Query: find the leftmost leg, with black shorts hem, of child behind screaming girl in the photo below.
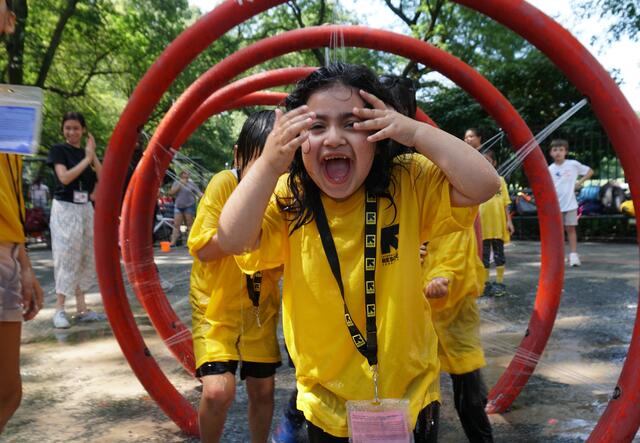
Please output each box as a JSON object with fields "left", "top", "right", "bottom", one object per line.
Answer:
{"left": 198, "top": 362, "right": 237, "bottom": 443}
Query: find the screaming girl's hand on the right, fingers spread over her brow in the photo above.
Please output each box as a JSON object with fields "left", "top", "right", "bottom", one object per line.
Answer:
{"left": 353, "top": 90, "right": 420, "bottom": 147}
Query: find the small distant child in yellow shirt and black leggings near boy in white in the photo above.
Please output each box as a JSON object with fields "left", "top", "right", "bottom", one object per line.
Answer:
{"left": 480, "top": 151, "right": 514, "bottom": 297}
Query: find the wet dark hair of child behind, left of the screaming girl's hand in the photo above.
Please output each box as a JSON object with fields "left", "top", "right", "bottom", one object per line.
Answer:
{"left": 236, "top": 111, "right": 276, "bottom": 178}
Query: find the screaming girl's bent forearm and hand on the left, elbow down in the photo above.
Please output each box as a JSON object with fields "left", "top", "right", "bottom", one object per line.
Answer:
{"left": 218, "top": 106, "right": 313, "bottom": 255}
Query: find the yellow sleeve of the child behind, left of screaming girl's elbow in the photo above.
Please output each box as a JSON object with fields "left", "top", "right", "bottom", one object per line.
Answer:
{"left": 187, "top": 171, "right": 238, "bottom": 257}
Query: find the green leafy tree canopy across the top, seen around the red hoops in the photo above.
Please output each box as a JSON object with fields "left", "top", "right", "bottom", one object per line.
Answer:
{"left": 0, "top": 0, "right": 638, "bottom": 184}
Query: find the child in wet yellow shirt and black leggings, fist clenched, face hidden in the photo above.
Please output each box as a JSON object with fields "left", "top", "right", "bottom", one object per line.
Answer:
{"left": 424, "top": 228, "right": 493, "bottom": 442}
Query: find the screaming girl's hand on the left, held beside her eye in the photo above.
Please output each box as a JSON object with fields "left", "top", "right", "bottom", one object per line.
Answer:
{"left": 262, "top": 105, "right": 315, "bottom": 175}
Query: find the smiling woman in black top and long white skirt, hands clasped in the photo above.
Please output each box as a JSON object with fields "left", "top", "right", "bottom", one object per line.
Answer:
{"left": 47, "top": 112, "right": 102, "bottom": 328}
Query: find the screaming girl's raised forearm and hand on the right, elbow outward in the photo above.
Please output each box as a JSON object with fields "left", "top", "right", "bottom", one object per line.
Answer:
{"left": 353, "top": 91, "right": 500, "bottom": 206}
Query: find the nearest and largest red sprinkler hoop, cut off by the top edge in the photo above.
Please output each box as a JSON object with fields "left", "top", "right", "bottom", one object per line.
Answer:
{"left": 96, "top": 0, "right": 640, "bottom": 441}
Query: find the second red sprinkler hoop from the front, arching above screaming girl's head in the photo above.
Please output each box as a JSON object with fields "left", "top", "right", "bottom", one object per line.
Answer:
{"left": 119, "top": 23, "right": 563, "bottom": 434}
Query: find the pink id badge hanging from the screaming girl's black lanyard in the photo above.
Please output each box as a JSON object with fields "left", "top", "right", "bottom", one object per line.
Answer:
{"left": 347, "top": 398, "right": 413, "bottom": 443}
